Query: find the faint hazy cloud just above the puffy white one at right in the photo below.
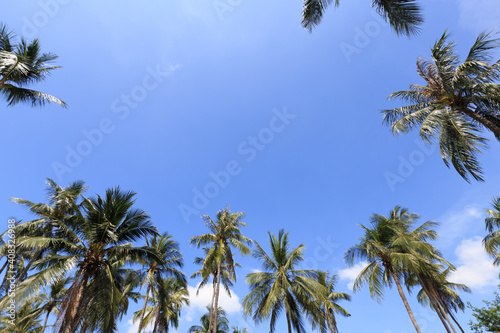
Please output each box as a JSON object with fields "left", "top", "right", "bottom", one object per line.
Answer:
{"left": 438, "top": 205, "right": 484, "bottom": 248}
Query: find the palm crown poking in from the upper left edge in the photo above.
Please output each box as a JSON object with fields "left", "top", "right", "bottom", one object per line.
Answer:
{"left": 0, "top": 24, "right": 67, "bottom": 108}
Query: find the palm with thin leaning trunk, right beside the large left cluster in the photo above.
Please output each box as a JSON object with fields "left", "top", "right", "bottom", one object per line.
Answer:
{"left": 138, "top": 233, "right": 186, "bottom": 333}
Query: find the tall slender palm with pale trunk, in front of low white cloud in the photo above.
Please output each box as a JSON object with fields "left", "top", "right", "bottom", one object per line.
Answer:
{"left": 190, "top": 206, "right": 252, "bottom": 333}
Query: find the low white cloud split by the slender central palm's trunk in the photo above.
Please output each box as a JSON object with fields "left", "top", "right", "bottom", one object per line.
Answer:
{"left": 185, "top": 284, "right": 242, "bottom": 321}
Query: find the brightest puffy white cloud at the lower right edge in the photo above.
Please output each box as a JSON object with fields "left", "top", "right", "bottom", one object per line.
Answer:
{"left": 449, "top": 236, "right": 500, "bottom": 289}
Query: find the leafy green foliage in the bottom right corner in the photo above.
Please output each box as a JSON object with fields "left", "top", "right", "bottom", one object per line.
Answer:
{"left": 467, "top": 292, "right": 500, "bottom": 333}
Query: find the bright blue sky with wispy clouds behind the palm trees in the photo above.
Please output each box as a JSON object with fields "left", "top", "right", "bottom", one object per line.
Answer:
{"left": 0, "top": 0, "right": 500, "bottom": 333}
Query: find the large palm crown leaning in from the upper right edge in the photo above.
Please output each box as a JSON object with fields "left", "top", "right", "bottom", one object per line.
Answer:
{"left": 382, "top": 32, "right": 500, "bottom": 181}
